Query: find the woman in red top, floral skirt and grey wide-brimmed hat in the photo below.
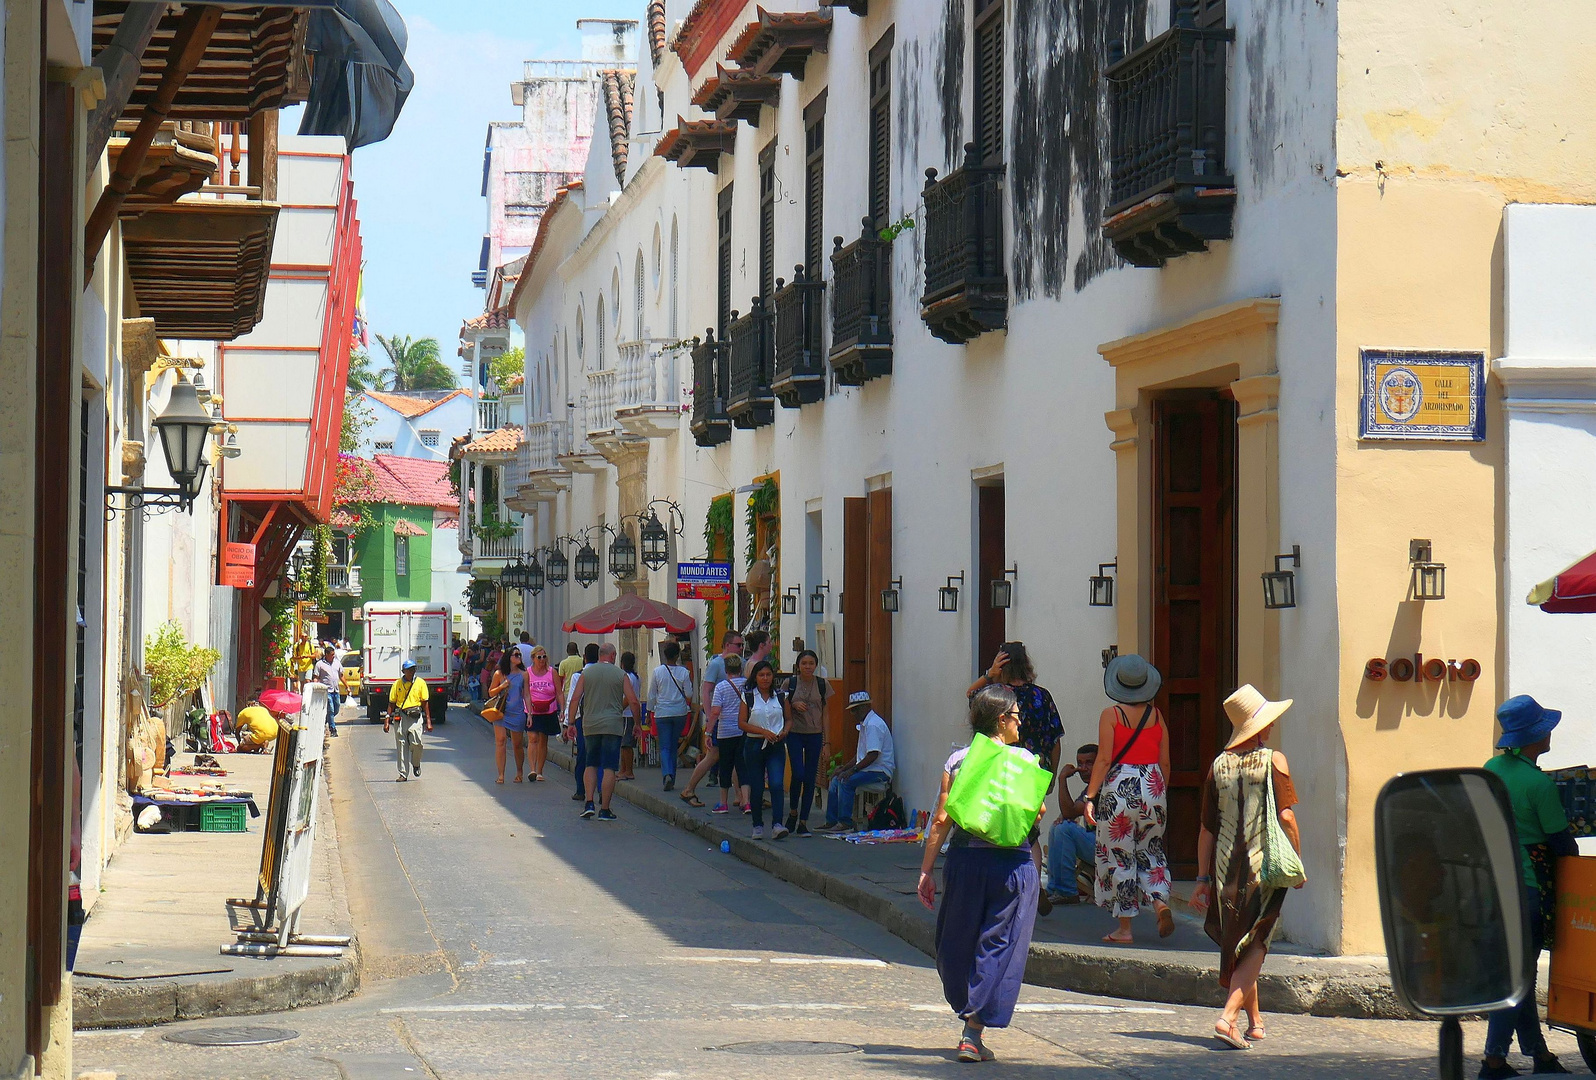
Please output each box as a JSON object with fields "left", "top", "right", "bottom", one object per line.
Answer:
{"left": 1085, "top": 654, "right": 1175, "bottom": 944}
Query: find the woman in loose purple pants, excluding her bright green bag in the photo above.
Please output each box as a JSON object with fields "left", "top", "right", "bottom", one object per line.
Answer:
{"left": 919, "top": 684, "right": 1041, "bottom": 1061}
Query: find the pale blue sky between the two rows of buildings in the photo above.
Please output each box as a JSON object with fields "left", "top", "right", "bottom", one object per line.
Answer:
{"left": 336, "top": 0, "right": 622, "bottom": 367}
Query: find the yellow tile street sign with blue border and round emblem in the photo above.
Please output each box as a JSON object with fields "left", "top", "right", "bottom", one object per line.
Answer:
{"left": 1358, "top": 349, "right": 1486, "bottom": 442}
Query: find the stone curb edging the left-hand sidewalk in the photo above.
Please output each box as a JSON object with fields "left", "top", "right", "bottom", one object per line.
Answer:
{"left": 72, "top": 737, "right": 361, "bottom": 1031}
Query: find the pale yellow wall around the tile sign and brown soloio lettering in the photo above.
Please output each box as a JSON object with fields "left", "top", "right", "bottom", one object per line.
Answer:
{"left": 1336, "top": 0, "right": 1596, "bottom": 952}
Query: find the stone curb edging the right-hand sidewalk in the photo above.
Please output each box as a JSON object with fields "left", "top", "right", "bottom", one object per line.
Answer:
{"left": 549, "top": 742, "right": 1416, "bottom": 1019}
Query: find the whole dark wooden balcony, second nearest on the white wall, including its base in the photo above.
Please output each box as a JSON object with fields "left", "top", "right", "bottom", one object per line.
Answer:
{"left": 919, "top": 144, "right": 1009, "bottom": 345}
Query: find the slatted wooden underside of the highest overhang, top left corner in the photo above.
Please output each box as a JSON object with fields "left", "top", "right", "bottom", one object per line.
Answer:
{"left": 94, "top": 0, "right": 310, "bottom": 121}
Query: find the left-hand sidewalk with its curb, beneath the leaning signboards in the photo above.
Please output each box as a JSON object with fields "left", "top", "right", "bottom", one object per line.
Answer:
{"left": 72, "top": 742, "right": 359, "bottom": 1029}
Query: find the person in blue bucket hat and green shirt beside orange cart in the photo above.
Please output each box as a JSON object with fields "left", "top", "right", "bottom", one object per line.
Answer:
{"left": 1479, "top": 694, "right": 1580, "bottom": 1080}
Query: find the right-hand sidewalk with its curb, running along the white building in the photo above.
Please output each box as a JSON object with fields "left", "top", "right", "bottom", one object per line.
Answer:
{"left": 549, "top": 733, "right": 1411, "bottom": 1019}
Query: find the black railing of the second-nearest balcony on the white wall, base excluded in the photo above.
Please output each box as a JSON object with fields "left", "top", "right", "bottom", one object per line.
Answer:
{"left": 921, "top": 144, "right": 1005, "bottom": 306}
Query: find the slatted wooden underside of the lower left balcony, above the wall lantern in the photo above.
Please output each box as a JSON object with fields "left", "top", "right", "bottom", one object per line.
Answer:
{"left": 121, "top": 198, "right": 278, "bottom": 341}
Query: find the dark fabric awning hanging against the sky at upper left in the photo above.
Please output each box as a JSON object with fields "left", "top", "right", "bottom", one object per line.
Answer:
{"left": 300, "top": 0, "right": 415, "bottom": 150}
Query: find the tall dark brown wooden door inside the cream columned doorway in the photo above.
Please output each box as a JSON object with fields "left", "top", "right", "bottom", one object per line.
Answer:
{"left": 1152, "top": 392, "right": 1235, "bottom": 877}
